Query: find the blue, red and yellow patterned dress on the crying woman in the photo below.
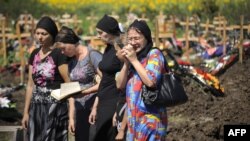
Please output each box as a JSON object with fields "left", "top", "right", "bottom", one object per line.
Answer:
{"left": 126, "top": 49, "right": 167, "bottom": 141}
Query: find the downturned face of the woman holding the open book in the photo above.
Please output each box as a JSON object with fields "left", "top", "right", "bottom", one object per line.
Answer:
{"left": 55, "top": 42, "right": 76, "bottom": 57}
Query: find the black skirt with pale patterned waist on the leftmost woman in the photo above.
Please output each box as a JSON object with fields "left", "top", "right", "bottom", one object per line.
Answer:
{"left": 27, "top": 89, "right": 68, "bottom": 141}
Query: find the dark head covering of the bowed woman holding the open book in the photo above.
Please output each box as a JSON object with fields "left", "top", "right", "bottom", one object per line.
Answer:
{"left": 55, "top": 26, "right": 80, "bottom": 44}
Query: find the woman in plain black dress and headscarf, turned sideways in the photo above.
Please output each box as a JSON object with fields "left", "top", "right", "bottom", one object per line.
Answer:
{"left": 89, "top": 15, "right": 122, "bottom": 141}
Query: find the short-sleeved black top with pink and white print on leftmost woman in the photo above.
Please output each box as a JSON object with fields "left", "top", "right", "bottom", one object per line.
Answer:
{"left": 29, "top": 48, "right": 67, "bottom": 89}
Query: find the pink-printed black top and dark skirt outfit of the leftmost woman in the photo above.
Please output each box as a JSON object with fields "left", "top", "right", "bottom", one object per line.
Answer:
{"left": 27, "top": 48, "right": 68, "bottom": 141}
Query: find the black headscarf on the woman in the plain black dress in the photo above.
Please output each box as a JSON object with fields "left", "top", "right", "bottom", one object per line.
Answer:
{"left": 96, "top": 14, "right": 121, "bottom": 36}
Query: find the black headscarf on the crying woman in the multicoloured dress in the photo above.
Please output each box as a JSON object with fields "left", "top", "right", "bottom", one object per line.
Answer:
{"left": 128, "top": 20, "right": 153, "bottom": 60}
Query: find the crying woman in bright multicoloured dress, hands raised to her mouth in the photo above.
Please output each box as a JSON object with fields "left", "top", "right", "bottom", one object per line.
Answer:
{"left": 117, "top": 20, "right": 167, "bottom": 141}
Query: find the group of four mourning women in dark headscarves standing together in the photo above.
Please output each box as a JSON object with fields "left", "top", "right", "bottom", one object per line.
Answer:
{"left": 22, "top": 15, "right": 168, "bottom": 141}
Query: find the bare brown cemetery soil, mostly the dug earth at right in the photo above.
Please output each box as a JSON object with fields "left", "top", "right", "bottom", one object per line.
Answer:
{"left": 0, "top": 59, "right": 250, "bottom": 141}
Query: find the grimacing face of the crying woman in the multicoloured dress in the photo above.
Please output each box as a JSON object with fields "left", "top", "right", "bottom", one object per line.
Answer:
{"left": 127, "top": 28, "right": 147, "bottom": 52}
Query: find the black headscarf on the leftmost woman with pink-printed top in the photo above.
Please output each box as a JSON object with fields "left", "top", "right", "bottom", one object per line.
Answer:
{"left": 36, "top": 16, "right": 58, "bottom": 40}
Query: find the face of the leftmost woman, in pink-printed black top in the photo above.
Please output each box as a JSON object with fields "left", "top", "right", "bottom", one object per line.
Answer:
{"left": 35, "top": 28, "right": 53, "bottom": 47}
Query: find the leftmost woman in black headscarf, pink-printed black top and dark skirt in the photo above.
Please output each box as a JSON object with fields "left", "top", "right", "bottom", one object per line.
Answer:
{"left": 22, "top": 17, "right": 70, "bottom": 141}
